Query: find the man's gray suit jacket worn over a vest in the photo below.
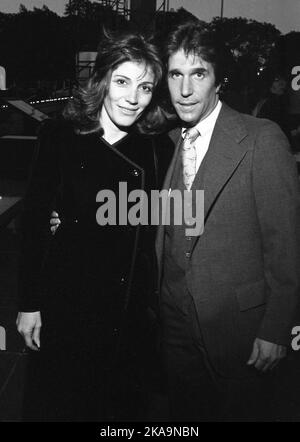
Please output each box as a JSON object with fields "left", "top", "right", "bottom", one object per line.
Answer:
{"left": 156, "top": 104, "right": 300, "bottom": 376}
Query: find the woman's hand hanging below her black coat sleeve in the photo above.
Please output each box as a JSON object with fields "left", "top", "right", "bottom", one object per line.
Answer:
{"left": 16, "top": 312, "right": 42, "bottom": 351}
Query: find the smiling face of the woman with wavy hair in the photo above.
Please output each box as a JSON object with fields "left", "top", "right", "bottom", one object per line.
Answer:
{"left": 101, "top": 61, "right": 154, "bottom": 130}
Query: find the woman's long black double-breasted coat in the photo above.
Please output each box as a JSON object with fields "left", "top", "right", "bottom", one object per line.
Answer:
{"left": 20, "top": 121, "right": 172, "bottom": 420}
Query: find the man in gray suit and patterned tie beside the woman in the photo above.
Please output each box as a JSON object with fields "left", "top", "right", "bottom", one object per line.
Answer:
{"left": 156, "top": 23, "right": 300, "bottom": 421}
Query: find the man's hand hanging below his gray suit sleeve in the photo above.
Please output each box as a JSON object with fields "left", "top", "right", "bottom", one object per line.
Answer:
{"left": 247, "top": 338, "right": 287, "bottom": 372}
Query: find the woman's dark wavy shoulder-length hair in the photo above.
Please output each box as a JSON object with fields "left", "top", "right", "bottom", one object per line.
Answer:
{"left": 63, "top": 31, "right": 165, "bottom": 134}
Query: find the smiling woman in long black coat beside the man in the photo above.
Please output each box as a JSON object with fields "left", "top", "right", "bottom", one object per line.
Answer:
{"left": 17, "top": 34, "right": 172, "bottom": 421}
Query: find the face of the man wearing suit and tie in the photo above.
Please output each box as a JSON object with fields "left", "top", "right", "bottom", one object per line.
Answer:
{"left": 168, "top": 49, "right": 220, "bottom": 126}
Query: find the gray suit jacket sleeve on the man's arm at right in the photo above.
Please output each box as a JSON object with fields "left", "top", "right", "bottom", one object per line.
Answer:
{"left": 253, "top": 121, "right": 300, "bottom": 345}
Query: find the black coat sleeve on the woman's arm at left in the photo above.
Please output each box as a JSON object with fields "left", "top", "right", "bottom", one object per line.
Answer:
{"left": 18, "top": 120, "right": 59, "bottom": 312}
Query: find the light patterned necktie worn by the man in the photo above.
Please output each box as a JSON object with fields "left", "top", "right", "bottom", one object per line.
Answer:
{"left": 181, "top": 127, "right": 200, "bottom": 190}
